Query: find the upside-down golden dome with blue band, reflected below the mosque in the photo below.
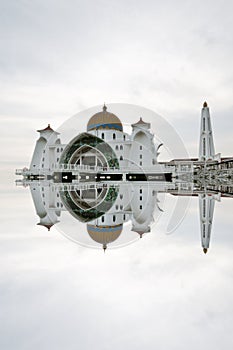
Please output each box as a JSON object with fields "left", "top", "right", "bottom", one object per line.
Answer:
{"left": 87, "top": 224, "right": 123, "bottom": 246}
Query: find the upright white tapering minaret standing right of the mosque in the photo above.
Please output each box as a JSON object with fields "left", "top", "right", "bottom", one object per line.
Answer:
{"left": 199, "top": 102, "right": 215, "bottom": 161}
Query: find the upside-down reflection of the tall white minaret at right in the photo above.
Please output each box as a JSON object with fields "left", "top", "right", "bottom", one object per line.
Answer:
{"left": 199, "top": 194, "right": 215, "bottom": 254}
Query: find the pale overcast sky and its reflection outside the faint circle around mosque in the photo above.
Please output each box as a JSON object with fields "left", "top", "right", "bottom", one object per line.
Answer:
{"left": 0, "top": 0, "right": 233, "bottom": 350}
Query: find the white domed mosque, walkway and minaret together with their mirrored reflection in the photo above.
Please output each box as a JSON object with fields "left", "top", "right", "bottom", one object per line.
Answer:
{"left": 16, "top": 103, "right": 233, "bottom": 253}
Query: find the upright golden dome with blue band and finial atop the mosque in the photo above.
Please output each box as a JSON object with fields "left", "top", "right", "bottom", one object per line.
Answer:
{"left": 87, "top": 105, "right": 123, "bottom": 131}
